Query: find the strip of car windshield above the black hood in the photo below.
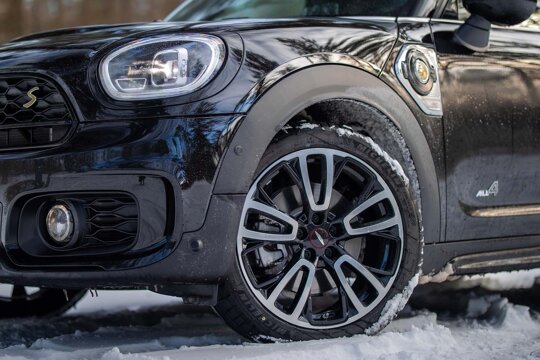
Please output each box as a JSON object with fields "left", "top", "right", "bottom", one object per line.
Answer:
{"left": 167, "top": 0, "right": 421, "bottom": 21}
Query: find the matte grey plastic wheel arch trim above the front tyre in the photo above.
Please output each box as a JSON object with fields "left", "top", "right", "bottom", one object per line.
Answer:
{"left": 214, "top": 64, "right": 441, "bottom": 243}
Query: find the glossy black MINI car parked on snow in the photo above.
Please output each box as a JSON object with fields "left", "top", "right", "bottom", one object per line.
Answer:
{"left": 0, "top": 0, "right": 540, "bottom": 341}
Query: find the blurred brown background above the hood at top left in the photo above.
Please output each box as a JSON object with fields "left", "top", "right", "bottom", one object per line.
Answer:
{"left": 0, "top": 0, "right": 182, "bottom": 43}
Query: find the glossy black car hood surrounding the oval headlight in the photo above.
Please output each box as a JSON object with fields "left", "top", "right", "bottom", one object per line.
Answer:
{"left": 0, "top": 18, "right": 397, "bottom": 121}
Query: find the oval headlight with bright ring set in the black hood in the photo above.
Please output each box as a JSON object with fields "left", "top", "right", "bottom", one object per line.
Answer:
{"left": 100, "top": 35, "right": 225, "bottom": 100}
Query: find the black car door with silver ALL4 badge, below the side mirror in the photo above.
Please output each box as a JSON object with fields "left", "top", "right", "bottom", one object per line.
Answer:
{"left": 432, "top": 20, "right": 540, "bottom": 241}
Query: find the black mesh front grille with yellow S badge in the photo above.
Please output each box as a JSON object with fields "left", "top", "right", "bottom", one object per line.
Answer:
{"left": 0, "top": 76, "right": 74, "bottom": 150}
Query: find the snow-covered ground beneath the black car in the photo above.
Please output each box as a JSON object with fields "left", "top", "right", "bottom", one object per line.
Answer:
{"left": 0, "top": 273, "right": 540, "bottom": 360}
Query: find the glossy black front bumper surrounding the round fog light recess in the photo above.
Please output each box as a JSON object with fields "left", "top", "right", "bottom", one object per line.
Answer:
{"left": 0, "top": 115, "right": 243, "bottom": 288}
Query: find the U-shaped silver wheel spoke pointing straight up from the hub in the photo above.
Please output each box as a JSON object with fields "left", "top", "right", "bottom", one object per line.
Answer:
{"left": 299, "top": 154, "right": 334, "bottom": 211}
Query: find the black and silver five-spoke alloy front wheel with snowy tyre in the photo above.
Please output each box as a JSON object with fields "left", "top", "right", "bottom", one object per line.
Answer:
{"left": 218, "top": 131, "right": 418, "bottom": 340}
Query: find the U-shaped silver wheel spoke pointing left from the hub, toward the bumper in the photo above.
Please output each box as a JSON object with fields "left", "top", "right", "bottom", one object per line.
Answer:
{"left": 241, "top": 200, "right": 298, "bottom": 242}
